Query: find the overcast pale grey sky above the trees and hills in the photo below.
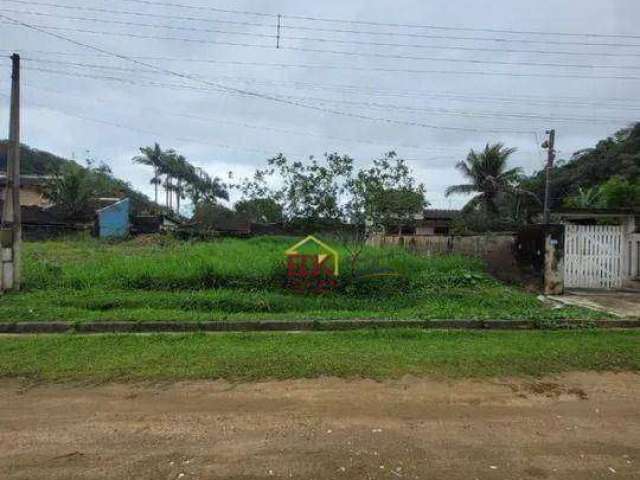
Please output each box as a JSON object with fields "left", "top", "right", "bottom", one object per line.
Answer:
{"left": 0, "top": 0, "right": 640, "bottom": 208}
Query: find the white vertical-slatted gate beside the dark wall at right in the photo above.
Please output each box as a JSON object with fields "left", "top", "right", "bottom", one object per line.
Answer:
{"left": 564, "top": 225, "right": 623, "bottom": 289}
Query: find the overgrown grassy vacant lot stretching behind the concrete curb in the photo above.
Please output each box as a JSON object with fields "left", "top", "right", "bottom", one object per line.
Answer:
{"left": 0, "top": 233, "right": 602, "bottom": 322}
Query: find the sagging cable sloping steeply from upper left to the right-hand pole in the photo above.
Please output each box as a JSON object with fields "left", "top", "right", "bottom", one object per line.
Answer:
{"left": 0, "top": 14, "right": 532, "bottom": 135}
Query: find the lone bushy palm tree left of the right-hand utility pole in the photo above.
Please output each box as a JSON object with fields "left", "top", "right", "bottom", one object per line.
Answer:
{"left": 446, "top": 143, "right": 522, "bottom": 213}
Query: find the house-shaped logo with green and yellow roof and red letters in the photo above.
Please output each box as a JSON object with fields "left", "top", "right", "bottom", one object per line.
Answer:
{"left": 285, "top": 235, "right": 340, "bottom": 277}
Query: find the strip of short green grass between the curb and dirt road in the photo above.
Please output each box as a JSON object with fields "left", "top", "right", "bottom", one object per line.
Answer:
{"left": 0, "top": 330, "right": 640, "bottom": 382}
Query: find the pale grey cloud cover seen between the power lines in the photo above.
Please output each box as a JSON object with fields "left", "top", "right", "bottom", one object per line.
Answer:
{"left": 0, "top": 0, "right": 640, "bottom": 207}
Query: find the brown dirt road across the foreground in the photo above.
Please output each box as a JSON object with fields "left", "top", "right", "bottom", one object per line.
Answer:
{"left": 0, "top": 374, "right": 640, "bottom": 480}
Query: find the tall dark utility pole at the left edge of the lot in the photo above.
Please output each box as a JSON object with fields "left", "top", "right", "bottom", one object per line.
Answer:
{"left": 0, "top": 53, "right": 22, "bottom": 291}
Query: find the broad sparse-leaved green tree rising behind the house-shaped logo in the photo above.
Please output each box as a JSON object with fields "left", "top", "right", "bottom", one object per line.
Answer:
{"left": 234, "top": 152, "right": 426, "bottom": 274}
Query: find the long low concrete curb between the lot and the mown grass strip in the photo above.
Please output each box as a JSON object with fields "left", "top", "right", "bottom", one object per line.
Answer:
{"left": 0, "top": 319, "right": 640, "bottom": 334}
